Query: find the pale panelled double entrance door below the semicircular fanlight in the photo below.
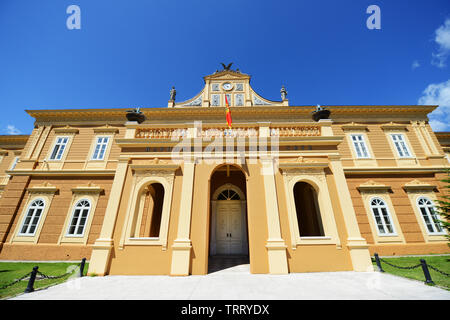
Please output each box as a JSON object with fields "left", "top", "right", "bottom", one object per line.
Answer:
{"left": 216, "top": 200, "right": 245, "bottom": 254}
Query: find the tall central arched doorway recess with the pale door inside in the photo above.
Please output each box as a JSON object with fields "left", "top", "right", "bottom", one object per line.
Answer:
{"left": 208, "top": 165, "right": 249, "bottom": 272}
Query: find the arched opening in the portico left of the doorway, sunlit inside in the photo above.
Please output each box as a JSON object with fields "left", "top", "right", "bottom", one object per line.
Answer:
{"left": 135, "top": 183, "right": 164, "bottom": 238}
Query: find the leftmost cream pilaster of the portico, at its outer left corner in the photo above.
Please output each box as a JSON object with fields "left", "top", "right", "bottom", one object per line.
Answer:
{"left": 88, "top": 158, "right": 128, "bottom": 276}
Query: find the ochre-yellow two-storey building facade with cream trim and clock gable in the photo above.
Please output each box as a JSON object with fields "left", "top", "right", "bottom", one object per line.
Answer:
{"left": 0, "top": 69, "right": 449, "bottom": 276}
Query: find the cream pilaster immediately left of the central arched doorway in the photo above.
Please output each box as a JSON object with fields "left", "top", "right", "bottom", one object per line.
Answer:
{"left": 170, "top": 160, "right": 195, "bottom": 276}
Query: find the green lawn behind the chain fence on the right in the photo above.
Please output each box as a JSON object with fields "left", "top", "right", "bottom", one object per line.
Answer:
{"left": 372, "top": 256, "right": 450, "bottom": 290}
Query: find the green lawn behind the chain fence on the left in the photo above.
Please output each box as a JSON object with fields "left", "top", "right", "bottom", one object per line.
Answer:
{"left": 0, "top": 262, "right": 89, "bottom": 299}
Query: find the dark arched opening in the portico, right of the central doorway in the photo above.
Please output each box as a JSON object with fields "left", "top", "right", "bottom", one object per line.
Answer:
{"left": 294, "top": 182, "right": 325, "bottom": 237}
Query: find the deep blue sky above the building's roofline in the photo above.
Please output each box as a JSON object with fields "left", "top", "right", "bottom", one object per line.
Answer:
{"left": 0, "top": 0, "right": 450, "bottom": 134}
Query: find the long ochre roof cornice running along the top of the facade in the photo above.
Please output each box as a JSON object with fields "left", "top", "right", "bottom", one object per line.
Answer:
{"left": 26, "top": 105, "right": 437, "bottom": 124}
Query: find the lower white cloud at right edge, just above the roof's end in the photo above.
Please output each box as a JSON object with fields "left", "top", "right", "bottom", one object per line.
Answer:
{"left": 418, "top": 80, "right": 450, "bottom": 131}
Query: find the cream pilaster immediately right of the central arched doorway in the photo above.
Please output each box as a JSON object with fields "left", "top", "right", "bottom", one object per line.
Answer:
{"left": 261, "top": 158, "right": 288, "bottom": 274}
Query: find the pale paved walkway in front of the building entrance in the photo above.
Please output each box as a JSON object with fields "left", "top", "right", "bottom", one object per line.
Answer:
{"left": 7, "top": 264, "right": 450, "bottom": 300}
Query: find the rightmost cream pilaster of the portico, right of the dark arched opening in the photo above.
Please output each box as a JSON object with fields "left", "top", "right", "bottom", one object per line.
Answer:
{"left": 329, "top": 156, "right": 373, "bottom": 271}
